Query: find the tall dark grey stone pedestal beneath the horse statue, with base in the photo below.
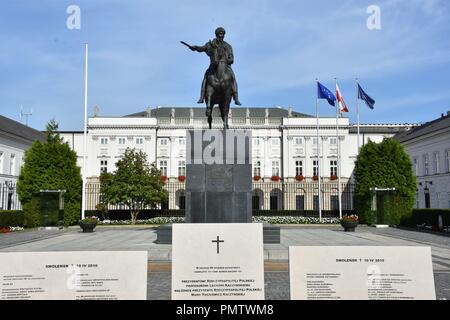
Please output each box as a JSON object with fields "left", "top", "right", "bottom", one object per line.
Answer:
{"left": 157, "top": 130, "right": 280, "bottom": 243}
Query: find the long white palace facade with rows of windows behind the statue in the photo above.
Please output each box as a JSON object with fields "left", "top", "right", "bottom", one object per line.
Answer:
{"left": 61, "top": 107, "right": 411, "bottom": 211}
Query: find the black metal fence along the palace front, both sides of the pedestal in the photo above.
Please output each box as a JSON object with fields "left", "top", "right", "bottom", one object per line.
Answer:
{"left": 86, "top": 181, "right": 355, "bottom": 220}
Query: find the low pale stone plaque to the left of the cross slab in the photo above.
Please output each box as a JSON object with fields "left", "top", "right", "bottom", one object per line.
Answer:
{"left": 0, "top": 251, "right": 148, "bottom": 300}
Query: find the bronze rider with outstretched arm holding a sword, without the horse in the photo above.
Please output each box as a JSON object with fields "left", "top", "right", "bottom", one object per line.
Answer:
{"left": 190, "top": 27, "right": 241, "bottom": 106}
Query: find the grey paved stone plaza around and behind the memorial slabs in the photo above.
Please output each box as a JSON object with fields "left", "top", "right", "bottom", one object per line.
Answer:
{"left": 0, "top": 226, "right": 450, "bottom": 300}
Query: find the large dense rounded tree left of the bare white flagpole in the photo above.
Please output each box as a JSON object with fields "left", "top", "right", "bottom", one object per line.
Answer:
{"left": 17, "top": 120, "right": 82, "bottom": 227}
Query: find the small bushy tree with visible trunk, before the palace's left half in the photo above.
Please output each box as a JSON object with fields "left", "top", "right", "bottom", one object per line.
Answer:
{"left": 100, "top": 148, "right": 167, "bottom": 224}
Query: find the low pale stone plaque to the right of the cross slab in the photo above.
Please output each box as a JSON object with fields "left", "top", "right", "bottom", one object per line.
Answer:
{"left": 289, "top": 246, "right": 436, "bottom": 300}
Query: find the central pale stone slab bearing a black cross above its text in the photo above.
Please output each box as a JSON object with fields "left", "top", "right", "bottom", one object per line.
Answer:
{"left": 172, "top": 222, "right": 264, "bottom": 300}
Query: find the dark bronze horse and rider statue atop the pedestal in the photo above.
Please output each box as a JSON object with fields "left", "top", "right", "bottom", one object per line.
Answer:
{"left": 181, "top": 27, "right": 241, "bottom": 129}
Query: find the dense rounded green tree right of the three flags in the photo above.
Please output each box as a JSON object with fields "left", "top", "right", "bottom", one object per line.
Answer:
{"left": 355, "top": 138, "right": 416, "bottom": 225}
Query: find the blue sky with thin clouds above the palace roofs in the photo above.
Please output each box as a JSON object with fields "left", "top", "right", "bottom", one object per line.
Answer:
{"left": 0, "top": 0, "right": 450, "bottom": 130}
